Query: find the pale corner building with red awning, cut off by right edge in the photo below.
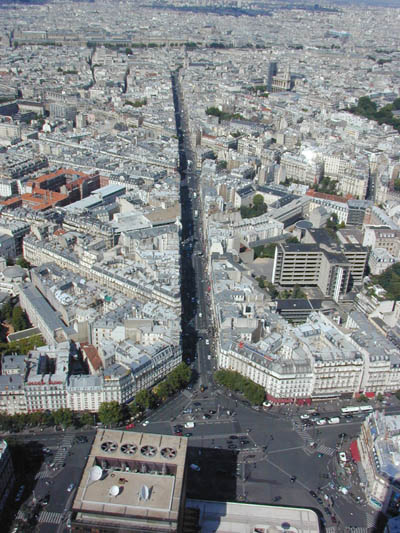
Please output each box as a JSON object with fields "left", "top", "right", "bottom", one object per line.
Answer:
{"left": 358, "top": 411, "right": 400, "bottom": 514}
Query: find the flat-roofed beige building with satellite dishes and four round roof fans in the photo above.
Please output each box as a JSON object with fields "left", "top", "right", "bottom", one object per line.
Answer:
{"left": 71, "top": 430, "right": 188, "bottom": 533}
